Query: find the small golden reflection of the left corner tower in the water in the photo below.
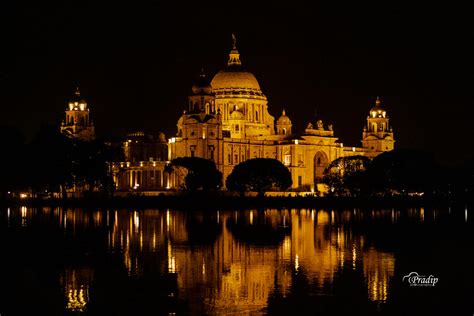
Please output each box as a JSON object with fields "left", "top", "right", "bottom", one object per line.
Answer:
{"left": 61, "top": 267, "right": 94, "bottom": 312}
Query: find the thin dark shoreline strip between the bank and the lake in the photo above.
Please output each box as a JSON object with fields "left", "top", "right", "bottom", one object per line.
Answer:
{"left": 0, "top": 194, "right": 473, "bottom": 210}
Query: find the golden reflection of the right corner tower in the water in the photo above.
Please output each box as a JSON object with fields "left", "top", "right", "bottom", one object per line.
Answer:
{"left": 362, "top": 248, "right": 395, "bottom": 302}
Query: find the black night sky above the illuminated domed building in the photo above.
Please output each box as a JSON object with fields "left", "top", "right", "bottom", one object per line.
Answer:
{"left": 0, "top": 1, "right": 474, "bottom": 163}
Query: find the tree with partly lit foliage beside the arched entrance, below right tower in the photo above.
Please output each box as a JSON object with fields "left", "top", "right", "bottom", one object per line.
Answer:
{"left": 323, "top": 156, "right": 370, "bottom": 196}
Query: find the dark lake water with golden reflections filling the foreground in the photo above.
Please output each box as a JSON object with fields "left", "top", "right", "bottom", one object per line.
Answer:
{"left": 0, "top": 207, "right": 474, "bottom": 316}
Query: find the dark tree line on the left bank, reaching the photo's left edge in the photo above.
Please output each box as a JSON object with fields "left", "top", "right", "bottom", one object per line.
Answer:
{"left": 0, "top": 125, "right": 120, "bottom": 198}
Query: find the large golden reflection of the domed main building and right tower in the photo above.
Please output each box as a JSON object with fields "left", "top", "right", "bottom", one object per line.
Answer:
{"left": 165, "top": 210, "right": 395, "bottom": 313}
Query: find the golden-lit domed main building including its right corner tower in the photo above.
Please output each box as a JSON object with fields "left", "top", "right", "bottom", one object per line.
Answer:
{"left": 169, "top": 38, "right": 395, "bottom": 191}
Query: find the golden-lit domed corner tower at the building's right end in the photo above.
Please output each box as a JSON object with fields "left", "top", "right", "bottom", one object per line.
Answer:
{"left": 362, "top": 97, "right": 395, "bottom": 158}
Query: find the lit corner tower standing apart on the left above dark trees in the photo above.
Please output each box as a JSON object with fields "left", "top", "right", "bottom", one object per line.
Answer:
{"left": 61, "top": 87, "right": 95, "bottom": 141}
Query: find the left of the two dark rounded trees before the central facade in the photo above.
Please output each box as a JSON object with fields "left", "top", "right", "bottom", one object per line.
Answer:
{"left": 166, "top": 157, "right": 222, "bottom": 192}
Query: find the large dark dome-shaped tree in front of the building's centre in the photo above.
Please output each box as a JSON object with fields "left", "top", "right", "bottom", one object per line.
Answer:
{"left": 226, "top": 158, "right": 293, "bottom": 196}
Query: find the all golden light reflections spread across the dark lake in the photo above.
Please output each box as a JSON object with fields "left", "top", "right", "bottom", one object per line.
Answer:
{"left": 2, "top": 207, "right": 468, "bottom": 314}
